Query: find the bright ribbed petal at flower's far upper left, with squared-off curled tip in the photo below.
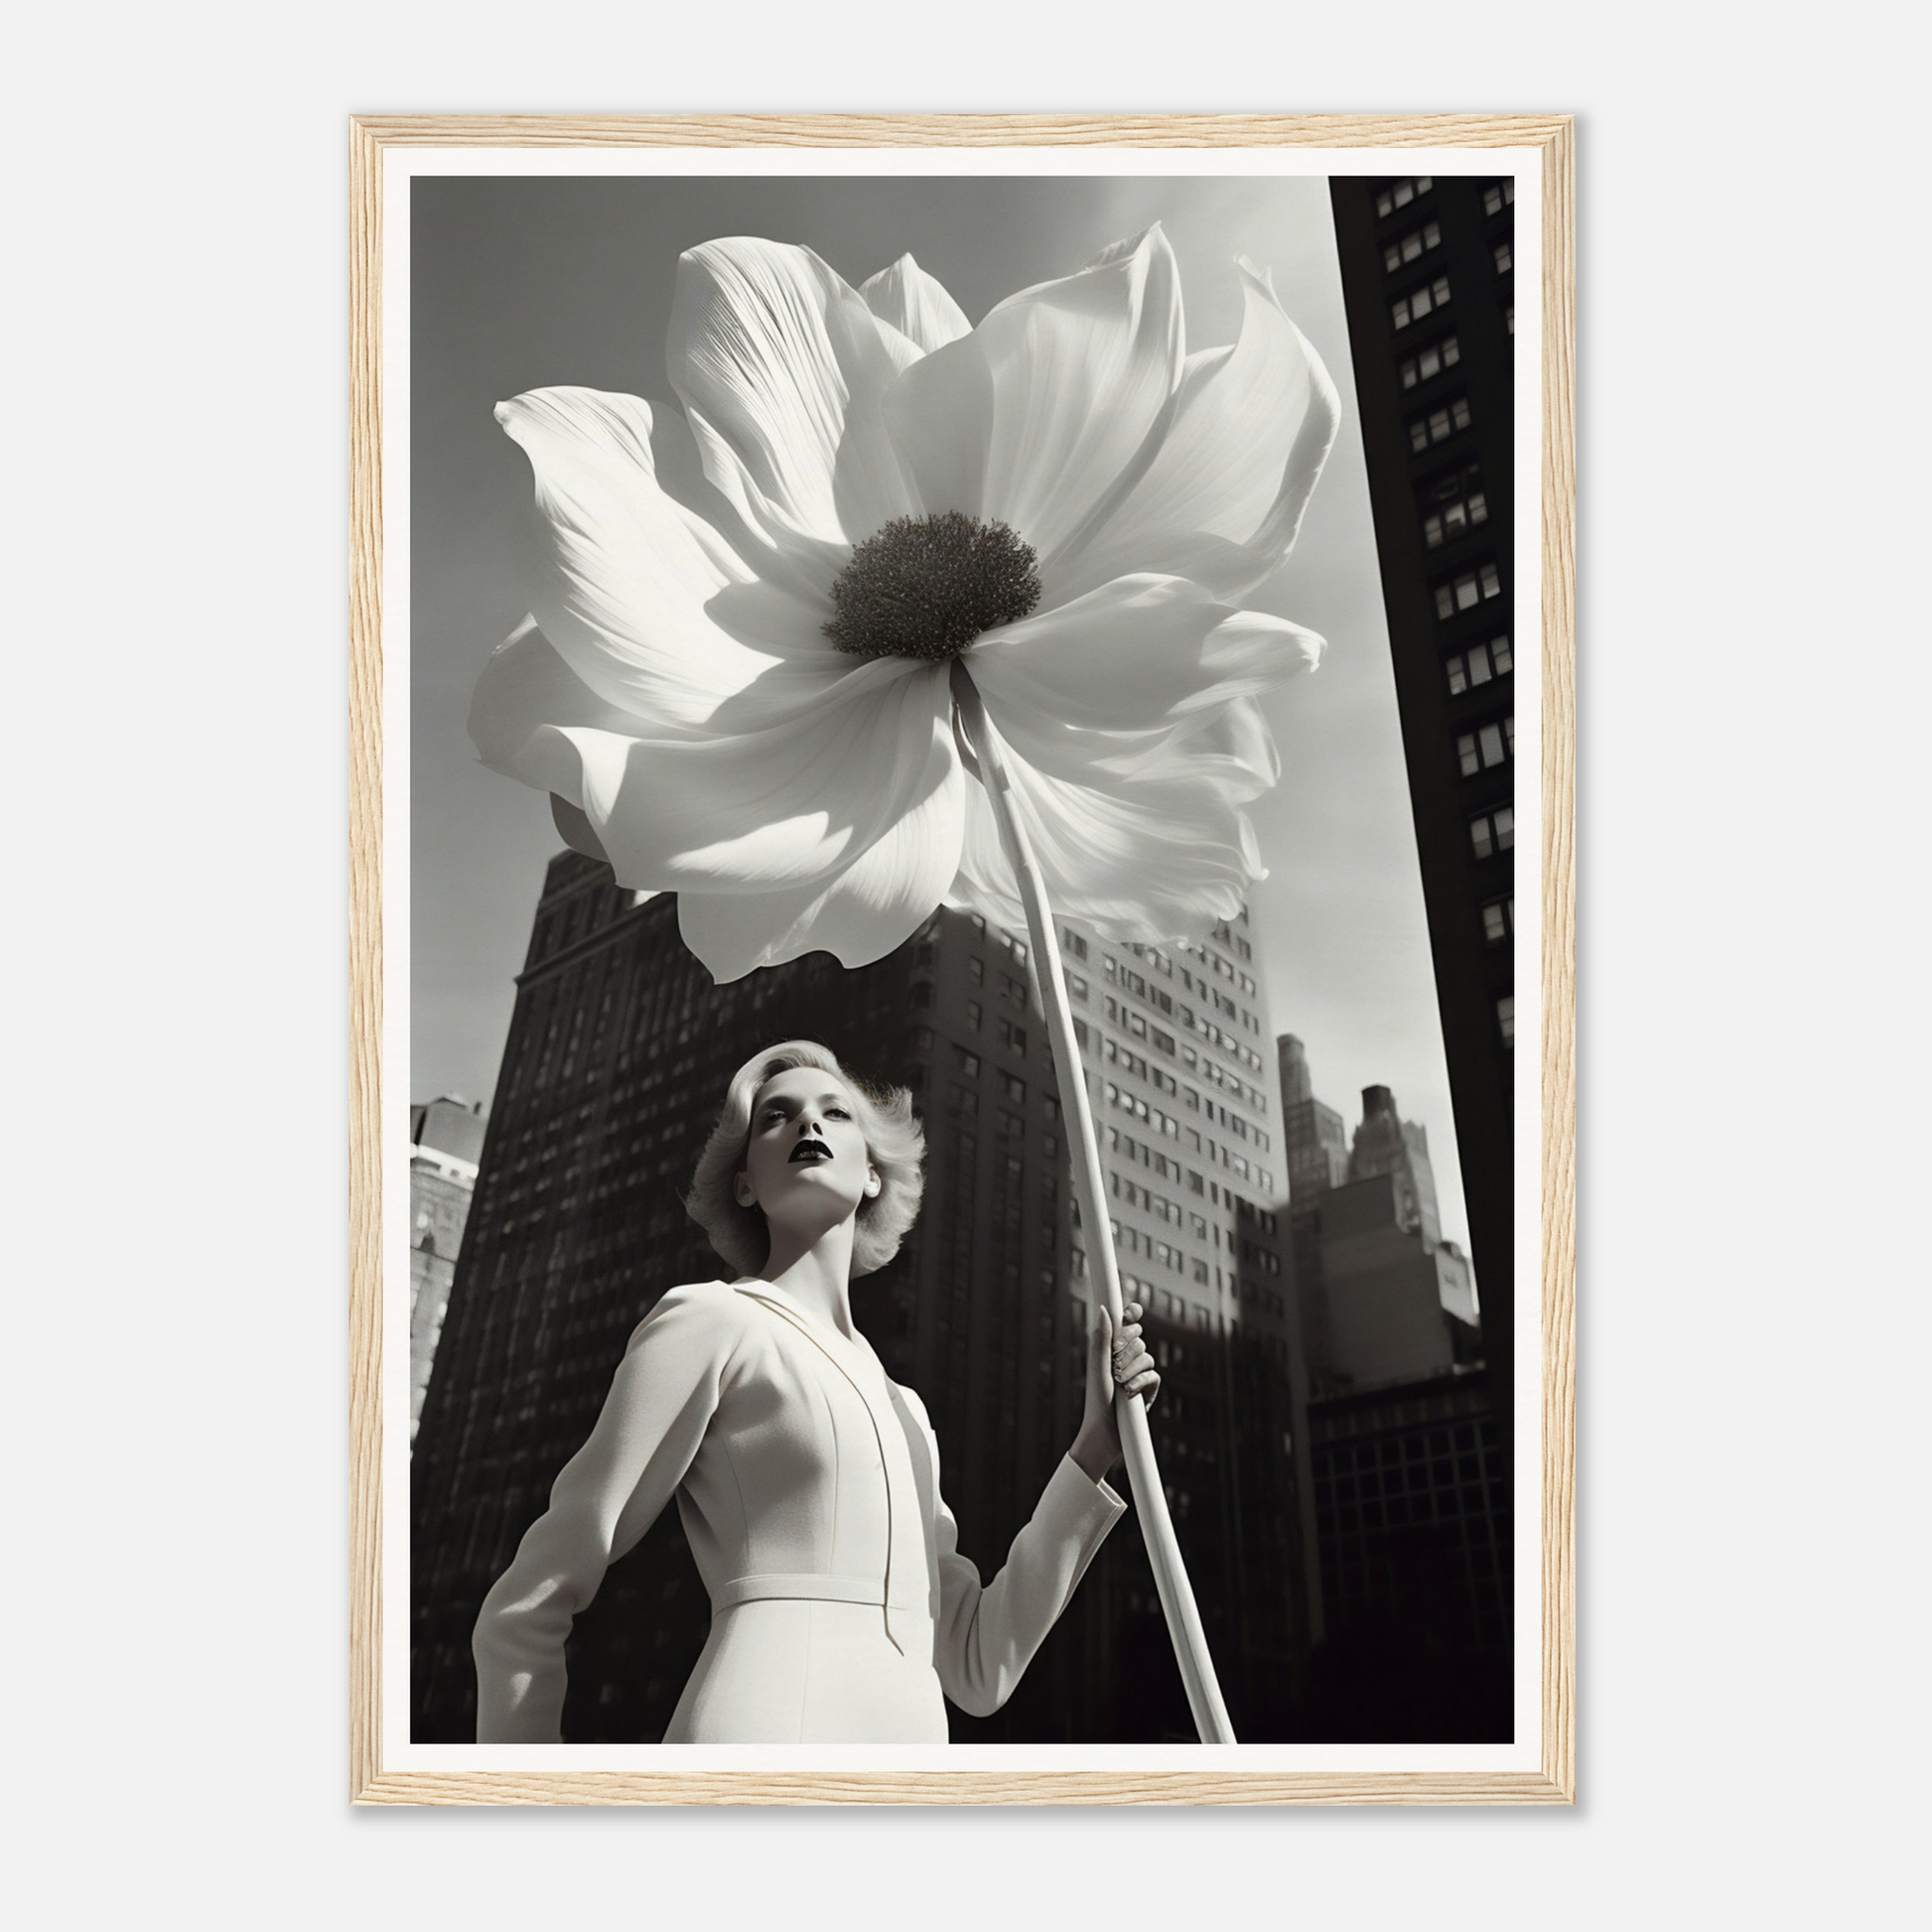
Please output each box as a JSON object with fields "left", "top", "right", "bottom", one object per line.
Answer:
{"left": 496, "top": 388, "right": 774, "bottom": 731}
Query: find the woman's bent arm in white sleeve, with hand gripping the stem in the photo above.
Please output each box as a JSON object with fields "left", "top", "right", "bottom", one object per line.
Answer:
{"left": 919, "top": 1303, "right": 1160, "bottom": 1718}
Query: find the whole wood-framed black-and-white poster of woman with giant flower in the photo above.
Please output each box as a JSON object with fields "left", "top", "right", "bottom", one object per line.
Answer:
{"left": 351, "top": 116, "right": 1575, "bottom": 1805}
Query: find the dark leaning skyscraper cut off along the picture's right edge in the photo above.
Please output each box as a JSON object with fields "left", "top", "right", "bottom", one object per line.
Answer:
{"left": 1329, "top": 176, "right": 1517, "bottom": 1444}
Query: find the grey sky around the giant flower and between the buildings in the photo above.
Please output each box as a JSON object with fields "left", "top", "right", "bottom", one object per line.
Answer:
{"left": 410, "top": 176, "right": 1468, "bottom": 1246}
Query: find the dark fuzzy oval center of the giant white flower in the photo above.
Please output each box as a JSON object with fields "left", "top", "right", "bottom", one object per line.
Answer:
{"left": 825, "top": 510, "right": 1039, "bottom": 661}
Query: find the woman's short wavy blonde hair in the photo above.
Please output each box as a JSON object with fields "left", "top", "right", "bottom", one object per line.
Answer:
{"left": 684, "top": 1039, "right": 925, "bottom": 1275}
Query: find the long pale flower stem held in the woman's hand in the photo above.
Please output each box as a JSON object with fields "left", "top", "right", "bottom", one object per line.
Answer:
{"left": 952, "top": 659, "right": 1234, "bottom": 1744}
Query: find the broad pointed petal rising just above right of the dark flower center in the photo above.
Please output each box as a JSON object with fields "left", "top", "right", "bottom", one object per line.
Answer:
{"left": 887, "top": 228, "right": 1182, "bottom": 564}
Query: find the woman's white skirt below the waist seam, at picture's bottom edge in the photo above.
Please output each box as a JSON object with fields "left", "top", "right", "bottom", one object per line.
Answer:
{"left": 664, "top": 1597, "right": 947, "bottom": 1744}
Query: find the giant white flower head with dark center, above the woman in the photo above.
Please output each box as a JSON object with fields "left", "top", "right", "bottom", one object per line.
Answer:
{"left": 470, "top": 228, "right": 1337, "bottom": 980}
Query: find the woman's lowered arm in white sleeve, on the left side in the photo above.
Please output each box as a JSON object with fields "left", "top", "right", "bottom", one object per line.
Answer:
{"left": 472, "top": 1287, "right": 736, "bottom": 1744}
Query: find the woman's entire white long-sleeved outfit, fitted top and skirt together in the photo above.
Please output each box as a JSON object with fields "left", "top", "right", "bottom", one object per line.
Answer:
{"left": 474, "top": 1281, "right": 1127, "bottom": 1742}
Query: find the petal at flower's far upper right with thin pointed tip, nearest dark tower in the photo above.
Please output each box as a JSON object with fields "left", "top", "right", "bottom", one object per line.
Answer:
{"left": 1064, "top": 261, "right": 1341, "bottom": 597}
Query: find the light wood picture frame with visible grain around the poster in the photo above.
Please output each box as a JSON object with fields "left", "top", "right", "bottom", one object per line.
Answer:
{"left": 349, "top": 114, "right": 1577, "bottom": 1805}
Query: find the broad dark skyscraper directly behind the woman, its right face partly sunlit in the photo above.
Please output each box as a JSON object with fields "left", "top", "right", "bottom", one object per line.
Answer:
{"left": 411, "top": 854, "right": 1311, "bottom": 1740}
